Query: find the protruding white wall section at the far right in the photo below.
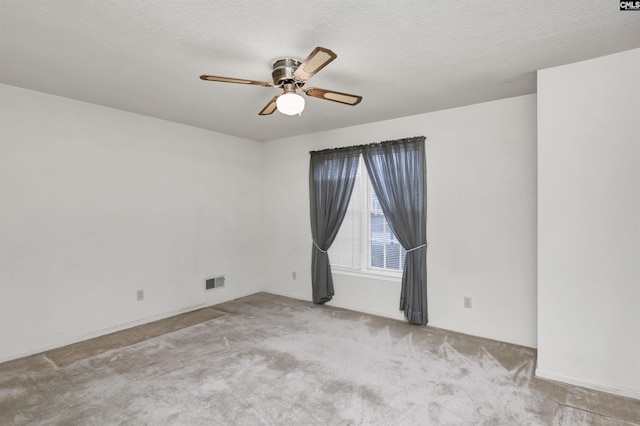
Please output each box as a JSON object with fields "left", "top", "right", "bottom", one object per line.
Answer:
{"left": 537, "top": 49, "right": 640, "bottom": 398}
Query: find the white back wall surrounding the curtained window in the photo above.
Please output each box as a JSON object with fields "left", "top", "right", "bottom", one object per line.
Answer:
{"left": 264, "top": 95, "right": 536, "bottom": 347}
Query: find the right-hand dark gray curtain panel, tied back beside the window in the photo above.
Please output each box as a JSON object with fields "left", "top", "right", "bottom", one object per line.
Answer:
{"left": 362, "top": 136, "right": 428, "bottom": 325}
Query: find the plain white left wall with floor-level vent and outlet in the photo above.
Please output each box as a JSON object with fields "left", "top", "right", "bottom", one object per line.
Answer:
{"left": 0, "top": 85, "right": 263, "bottom": 361}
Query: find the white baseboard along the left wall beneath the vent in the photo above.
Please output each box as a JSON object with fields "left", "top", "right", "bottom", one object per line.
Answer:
{"left": 0, "top": 290, "right": 262, "bottom": 363}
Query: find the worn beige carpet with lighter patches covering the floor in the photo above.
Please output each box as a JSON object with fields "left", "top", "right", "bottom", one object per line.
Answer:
{"left": 0, "top": 293, "right": 640, "bottom": 426}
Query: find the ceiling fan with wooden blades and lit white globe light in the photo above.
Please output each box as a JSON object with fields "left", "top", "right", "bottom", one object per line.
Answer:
{"left": 200, "top": 47, "right": 362, "bottom": 115}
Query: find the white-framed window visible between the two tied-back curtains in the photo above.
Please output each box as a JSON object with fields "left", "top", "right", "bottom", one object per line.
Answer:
{"left": 329, "top": 158, "right": 406, "bottom": 275}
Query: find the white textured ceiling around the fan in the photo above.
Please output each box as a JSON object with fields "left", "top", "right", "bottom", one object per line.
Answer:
{"left": 0, "top": 0, "right": 640, "bottom": 140}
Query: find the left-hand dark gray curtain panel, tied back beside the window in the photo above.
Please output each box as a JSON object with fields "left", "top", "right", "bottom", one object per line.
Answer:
{"left": 309, "top": 148, "right": 360, "bottom": 304}
